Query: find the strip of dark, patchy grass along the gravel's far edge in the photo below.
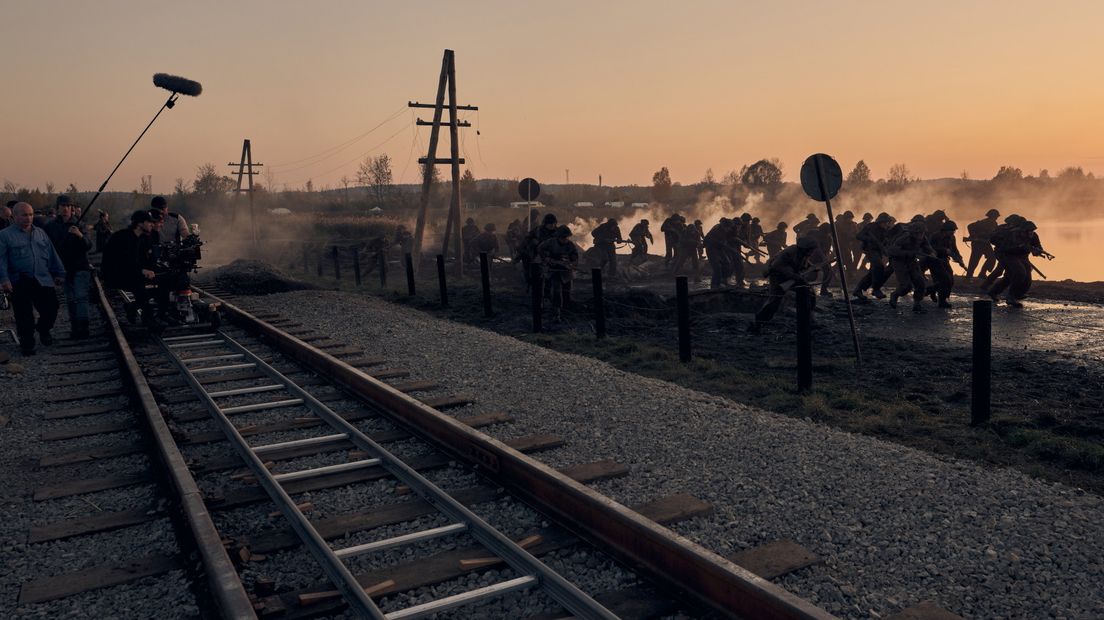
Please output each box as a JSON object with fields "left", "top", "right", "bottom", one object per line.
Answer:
{"left": 287, "top": 265, "right": 1104, "bottom": 492}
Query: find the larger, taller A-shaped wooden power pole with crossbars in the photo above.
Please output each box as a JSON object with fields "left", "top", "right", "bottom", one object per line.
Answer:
{"left": 406, "top": 50, "right": 479, "bottom": 275}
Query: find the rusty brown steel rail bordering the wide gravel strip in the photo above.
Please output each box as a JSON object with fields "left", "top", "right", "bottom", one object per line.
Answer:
{"left": 200, "top": 287, "right": 835, "bottom": 620}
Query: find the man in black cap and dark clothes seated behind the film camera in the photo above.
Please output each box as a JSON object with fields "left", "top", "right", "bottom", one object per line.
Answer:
{"left": 100, "top": 210, "right": 153, "bottom": 323}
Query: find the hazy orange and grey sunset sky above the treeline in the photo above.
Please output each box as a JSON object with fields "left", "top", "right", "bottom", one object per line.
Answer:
{"left": 0, "top": 0, "right": 1104, "bottom": 192}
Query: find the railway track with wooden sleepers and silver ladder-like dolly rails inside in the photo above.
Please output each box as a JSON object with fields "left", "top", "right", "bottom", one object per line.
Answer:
{"left": 10, "top": 275, "right": 843, "bottom": 618}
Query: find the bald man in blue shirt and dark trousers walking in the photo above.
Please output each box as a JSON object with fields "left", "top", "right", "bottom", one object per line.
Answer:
{"left": 0, "top": 202, "right": 65, "bottom": 355}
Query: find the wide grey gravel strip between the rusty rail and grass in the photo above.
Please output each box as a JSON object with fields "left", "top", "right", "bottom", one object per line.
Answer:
{"left": 224, "top": 291, "right": 1104, "bottom": 618}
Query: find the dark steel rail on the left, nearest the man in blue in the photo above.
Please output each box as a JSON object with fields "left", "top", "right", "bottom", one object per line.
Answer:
{"left": 93, "top": 275, "right": 257, "bottom": 620}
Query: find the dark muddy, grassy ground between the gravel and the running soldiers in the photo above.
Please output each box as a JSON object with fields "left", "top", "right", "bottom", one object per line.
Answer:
{"left": 208, "top": 253, "right": 1104, "bottom": 493}
